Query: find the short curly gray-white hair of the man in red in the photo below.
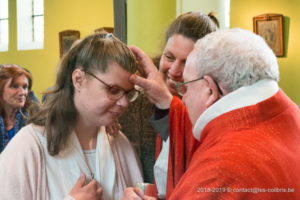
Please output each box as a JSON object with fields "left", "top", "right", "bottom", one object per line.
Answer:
{"left": 195, "top": 28, "right": 279, "bottom": 92}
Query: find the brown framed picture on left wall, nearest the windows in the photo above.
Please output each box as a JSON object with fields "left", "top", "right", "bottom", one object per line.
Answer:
{"left": 59, "top": 30, "right": 80, "bottom": 57}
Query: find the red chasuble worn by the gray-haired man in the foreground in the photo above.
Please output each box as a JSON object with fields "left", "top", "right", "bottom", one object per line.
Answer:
{"left": 170, "top": 90, "right": 300, "bottom": 200}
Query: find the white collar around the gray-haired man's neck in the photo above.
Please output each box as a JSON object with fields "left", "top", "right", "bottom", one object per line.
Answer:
{"left": 193, "top": 80, "right": 279, "bottom": 140}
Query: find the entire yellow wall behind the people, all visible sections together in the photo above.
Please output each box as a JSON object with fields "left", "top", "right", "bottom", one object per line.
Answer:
{"left": 0, "top": 0, "right": 300, "bottom": 104}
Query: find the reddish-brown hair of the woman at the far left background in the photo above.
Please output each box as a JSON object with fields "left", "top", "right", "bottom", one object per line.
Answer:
{"left": 0, "top": 64, "right": 32, "bottom": 115}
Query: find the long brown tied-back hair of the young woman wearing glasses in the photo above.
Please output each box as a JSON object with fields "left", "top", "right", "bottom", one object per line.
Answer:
{"left": 29, "top": 33, "right": 137, "bottom": 155}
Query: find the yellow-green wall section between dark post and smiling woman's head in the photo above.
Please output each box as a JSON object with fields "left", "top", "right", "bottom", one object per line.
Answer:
{"left": 127, "top": 0, "right": 176, "bottom": 55}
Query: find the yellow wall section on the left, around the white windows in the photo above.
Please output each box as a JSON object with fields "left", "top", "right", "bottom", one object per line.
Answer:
{"left": 0, "top": 0, "right": 114, "bottom": 99}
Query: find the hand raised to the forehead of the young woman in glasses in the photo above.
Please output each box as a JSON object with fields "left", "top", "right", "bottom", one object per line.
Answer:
{"left": 129, "top": 46, "right": 173, "bottom": 109}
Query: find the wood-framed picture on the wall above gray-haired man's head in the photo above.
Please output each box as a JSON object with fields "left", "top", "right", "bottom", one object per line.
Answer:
{"left": 253, "top": 14, "right": 284, "bottom": 57}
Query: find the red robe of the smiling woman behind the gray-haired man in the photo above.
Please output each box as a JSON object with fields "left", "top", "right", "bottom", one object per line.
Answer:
{"left": 155, "top": 96, "right": 199, "bottom": 199}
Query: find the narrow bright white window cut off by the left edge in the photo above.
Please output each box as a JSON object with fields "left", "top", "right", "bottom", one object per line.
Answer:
{"left": 0, "top": 0, "right": 9, "bottom": 52}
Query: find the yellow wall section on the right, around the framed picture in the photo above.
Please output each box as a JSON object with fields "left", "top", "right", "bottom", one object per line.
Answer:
{"left": 230, "top": 0, "right": 300, "bottom": 105}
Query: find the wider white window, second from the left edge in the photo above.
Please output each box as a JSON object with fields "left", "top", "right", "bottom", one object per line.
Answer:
{"left": 17, "top": 0, "right": 44, "bottom": 50}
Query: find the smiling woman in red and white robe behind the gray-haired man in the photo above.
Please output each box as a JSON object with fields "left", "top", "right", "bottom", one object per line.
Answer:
{"left": 123, "top": 12, "right": 219, "bottom": 199}
